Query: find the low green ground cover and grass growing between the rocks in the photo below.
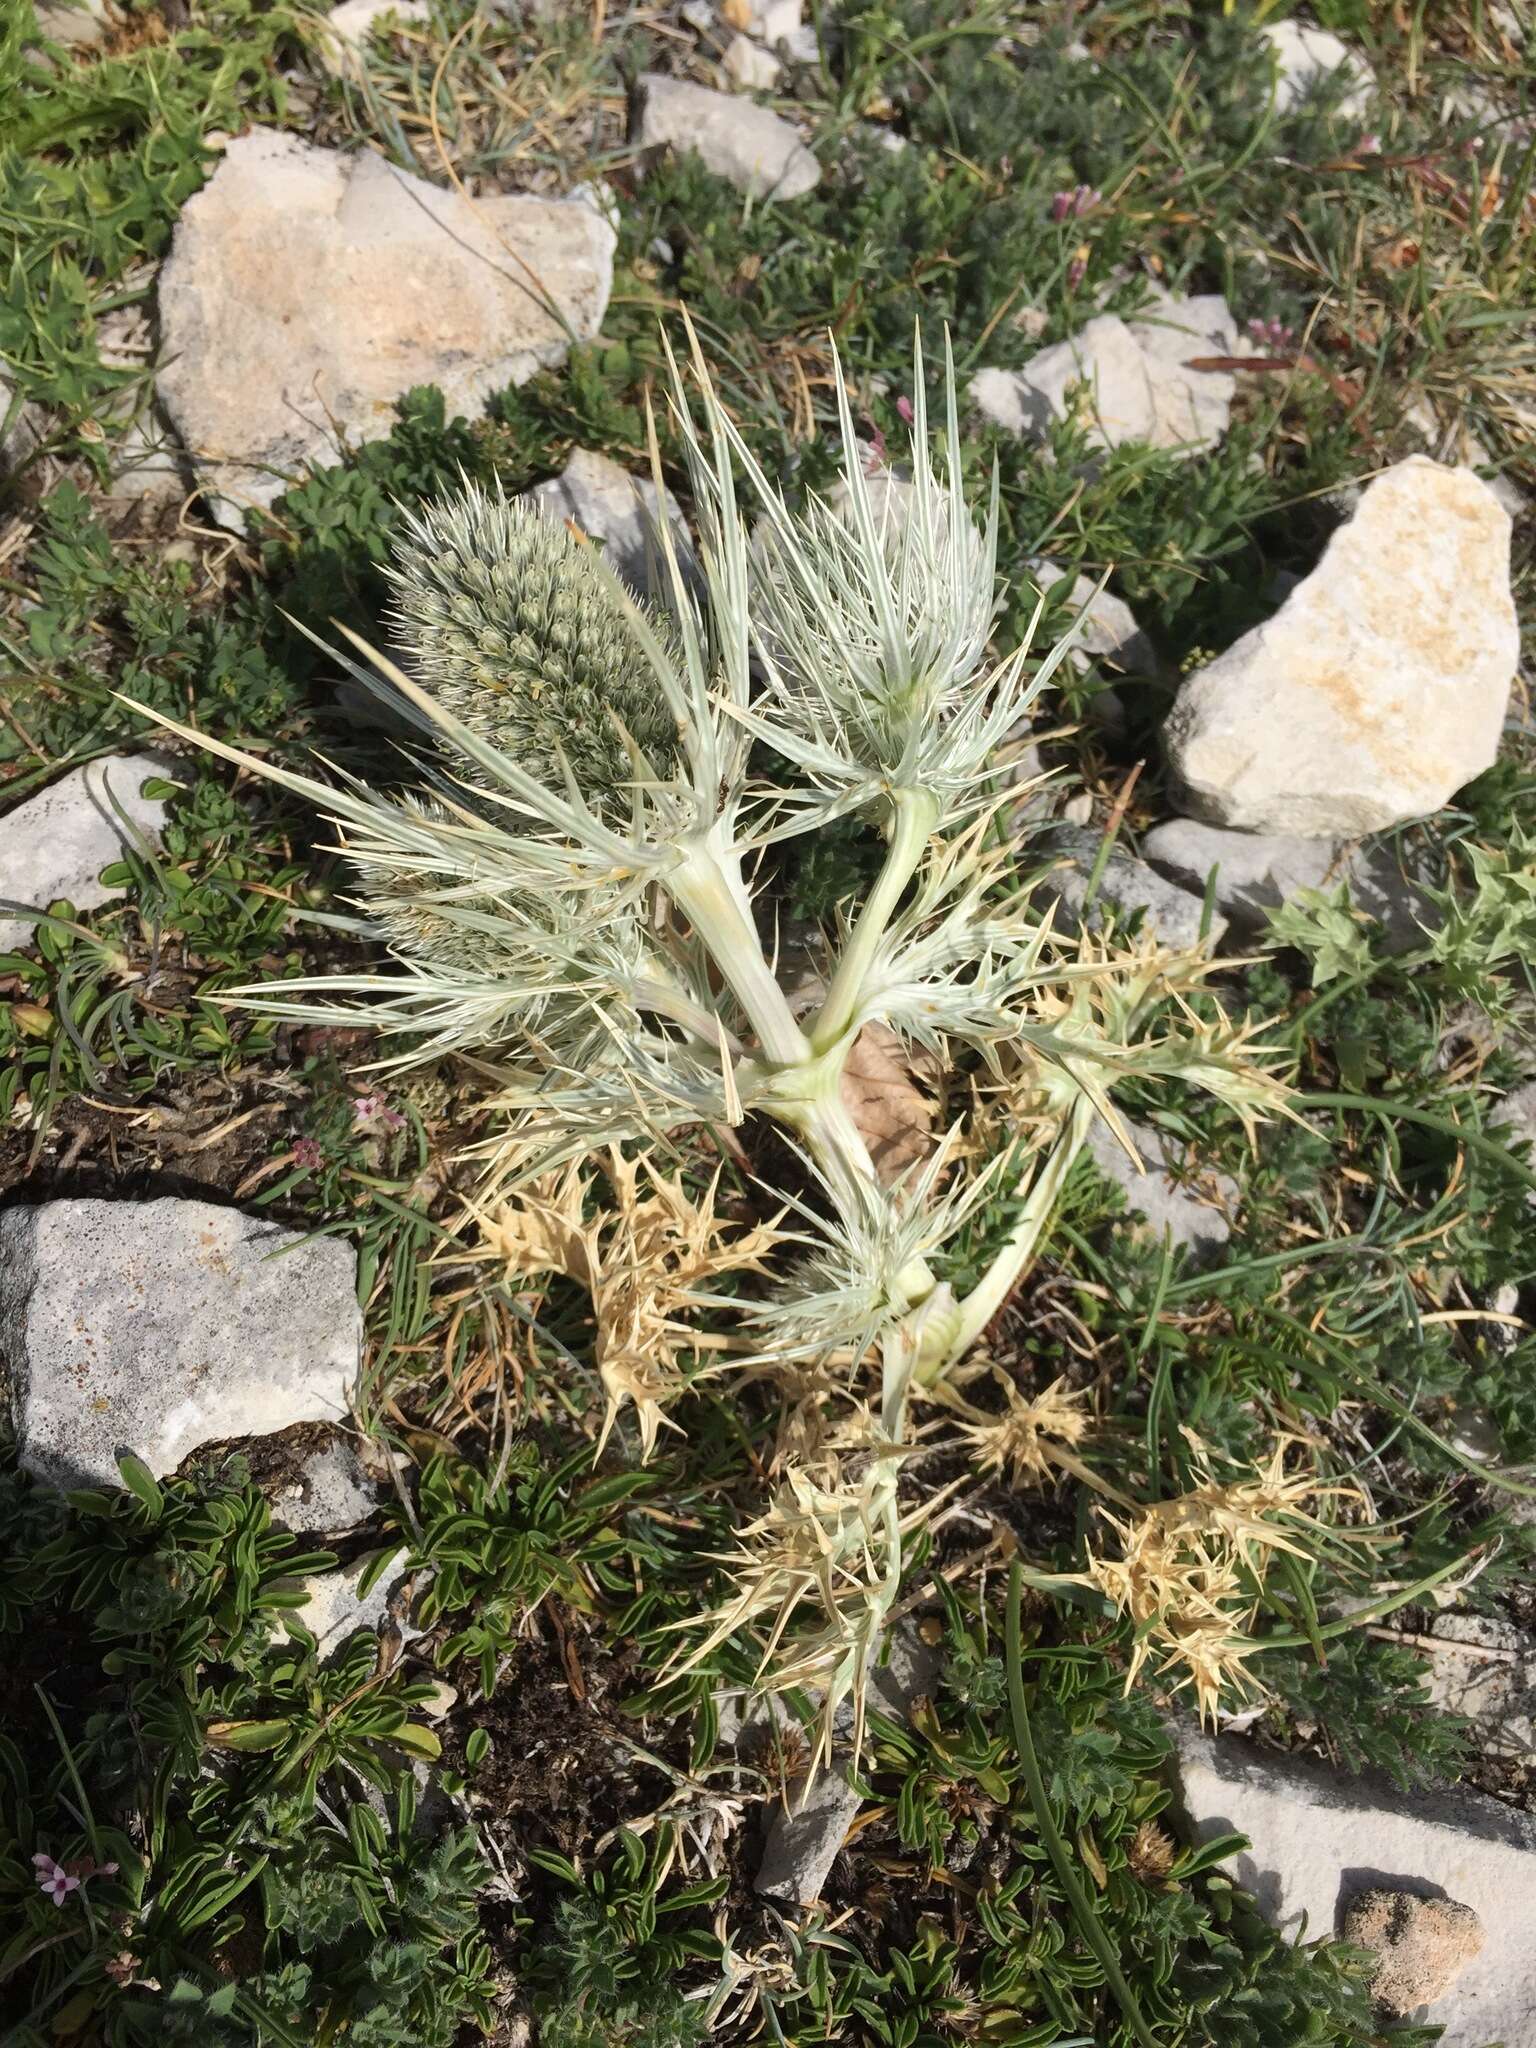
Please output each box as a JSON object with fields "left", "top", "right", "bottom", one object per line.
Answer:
{"left": 0, "top": 0, "right": 1536, "bottom": 2048}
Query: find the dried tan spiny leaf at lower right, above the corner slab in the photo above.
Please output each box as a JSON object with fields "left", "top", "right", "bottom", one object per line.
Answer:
{"left": 1069, "top": 1440, "right": 1360, "bottom": 1720}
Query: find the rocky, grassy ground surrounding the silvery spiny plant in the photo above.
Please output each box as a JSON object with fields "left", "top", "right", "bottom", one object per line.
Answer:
{"left": 0, "top": 0, "right": 1536, "bottom": 2048}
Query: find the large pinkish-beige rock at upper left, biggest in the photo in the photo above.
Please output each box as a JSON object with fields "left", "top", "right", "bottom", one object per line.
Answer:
{"left": 158, "top": 129, "right": 616, "bottom": 524}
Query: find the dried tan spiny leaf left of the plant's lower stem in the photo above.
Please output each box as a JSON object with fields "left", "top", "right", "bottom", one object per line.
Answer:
{"left": 475, "top": 1151, "right": 780, "bottom": 1458}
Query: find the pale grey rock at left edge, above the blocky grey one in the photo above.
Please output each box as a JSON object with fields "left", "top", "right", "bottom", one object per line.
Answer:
{"left": 0, "top": 754, "right": 178, "bottom": 952}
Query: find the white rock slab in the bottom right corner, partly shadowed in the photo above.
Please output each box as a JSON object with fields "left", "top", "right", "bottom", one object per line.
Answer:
{"left": 1178, "top": 1729, "right": 1536, "bottom": 2048}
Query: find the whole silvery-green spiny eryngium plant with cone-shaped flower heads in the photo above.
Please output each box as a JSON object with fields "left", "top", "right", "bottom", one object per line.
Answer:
{"left": 132, "top": 327, "right": 1282, "bottom": 1769}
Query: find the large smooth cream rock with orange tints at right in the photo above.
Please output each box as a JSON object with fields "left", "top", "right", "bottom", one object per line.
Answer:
{"left": 1163, "top": 455, "right": 1520, "bottom": 838}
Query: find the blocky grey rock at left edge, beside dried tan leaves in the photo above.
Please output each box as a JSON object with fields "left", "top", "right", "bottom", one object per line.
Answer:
{"left": 0, "top": 1196, "right": 362, "bottom": 1487}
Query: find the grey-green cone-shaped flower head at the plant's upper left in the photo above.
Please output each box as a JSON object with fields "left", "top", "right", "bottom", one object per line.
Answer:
{"left": 387, "top": 483, "right": 678, "bottom": 811}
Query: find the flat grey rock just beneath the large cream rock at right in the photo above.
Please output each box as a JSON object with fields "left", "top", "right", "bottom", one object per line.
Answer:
{"left": 1141, "top": 817, "right": 1436, "bottom": 952}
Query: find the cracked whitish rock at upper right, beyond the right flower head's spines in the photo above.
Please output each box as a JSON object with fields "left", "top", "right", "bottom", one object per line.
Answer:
{"left": 971, "top": 291, "right": 1249, "bottom": 455}
